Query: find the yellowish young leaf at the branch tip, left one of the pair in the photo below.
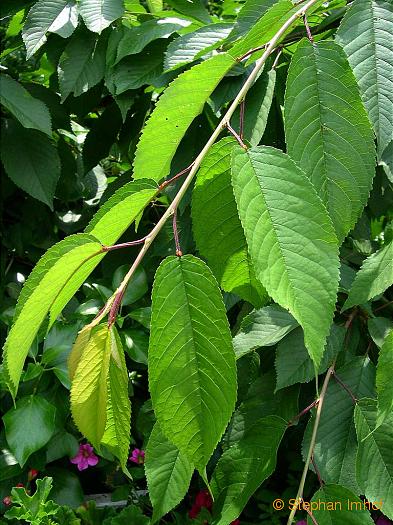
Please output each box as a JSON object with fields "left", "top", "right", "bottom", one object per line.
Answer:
{"left": 71, "top": 324, "right": 113, "bottom": 448}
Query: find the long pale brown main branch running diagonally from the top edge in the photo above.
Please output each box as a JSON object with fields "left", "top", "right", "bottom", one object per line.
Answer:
{"left": 96, "top": 0, "right": 321, "bottom": 327}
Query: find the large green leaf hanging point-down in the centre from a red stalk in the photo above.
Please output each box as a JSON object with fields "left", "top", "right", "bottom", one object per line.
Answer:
{"left": 149, "top": 255, "right": 236, "bottom": 472}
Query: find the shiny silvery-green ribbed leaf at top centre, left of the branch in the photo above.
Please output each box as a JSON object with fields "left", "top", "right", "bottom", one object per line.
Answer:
{"left": 164, "top": 23, "right": 232, "bottom": 70}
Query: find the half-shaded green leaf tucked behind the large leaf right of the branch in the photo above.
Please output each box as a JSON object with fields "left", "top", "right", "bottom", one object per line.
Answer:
{"left": 192, "top": 138, "right": 266, "bottom": 307}
